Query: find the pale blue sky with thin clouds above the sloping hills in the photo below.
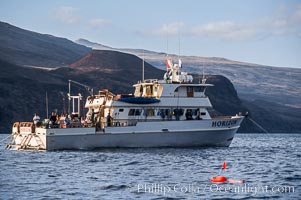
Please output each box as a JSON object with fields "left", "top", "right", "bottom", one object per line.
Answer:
{"left": 0, "top": 0, "right": 301, "bottom": 68}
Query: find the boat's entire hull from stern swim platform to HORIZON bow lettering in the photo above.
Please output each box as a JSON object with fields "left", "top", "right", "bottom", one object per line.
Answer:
{"left": 8, "top": 116, "right": 244, "bottom": 150}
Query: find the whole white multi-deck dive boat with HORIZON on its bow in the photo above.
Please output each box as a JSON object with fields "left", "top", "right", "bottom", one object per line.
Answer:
{"left": 7, "top": 59, "right": 244, "bottom": 150}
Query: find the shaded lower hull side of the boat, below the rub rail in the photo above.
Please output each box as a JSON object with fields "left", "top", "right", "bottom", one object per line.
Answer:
{"left": 46, "top": 128, "right": 237, "bottom": 150}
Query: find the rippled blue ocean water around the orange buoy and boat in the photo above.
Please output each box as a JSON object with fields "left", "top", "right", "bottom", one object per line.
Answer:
{"left": 0, "top": 134, "right": 301, "bottom": 200}
